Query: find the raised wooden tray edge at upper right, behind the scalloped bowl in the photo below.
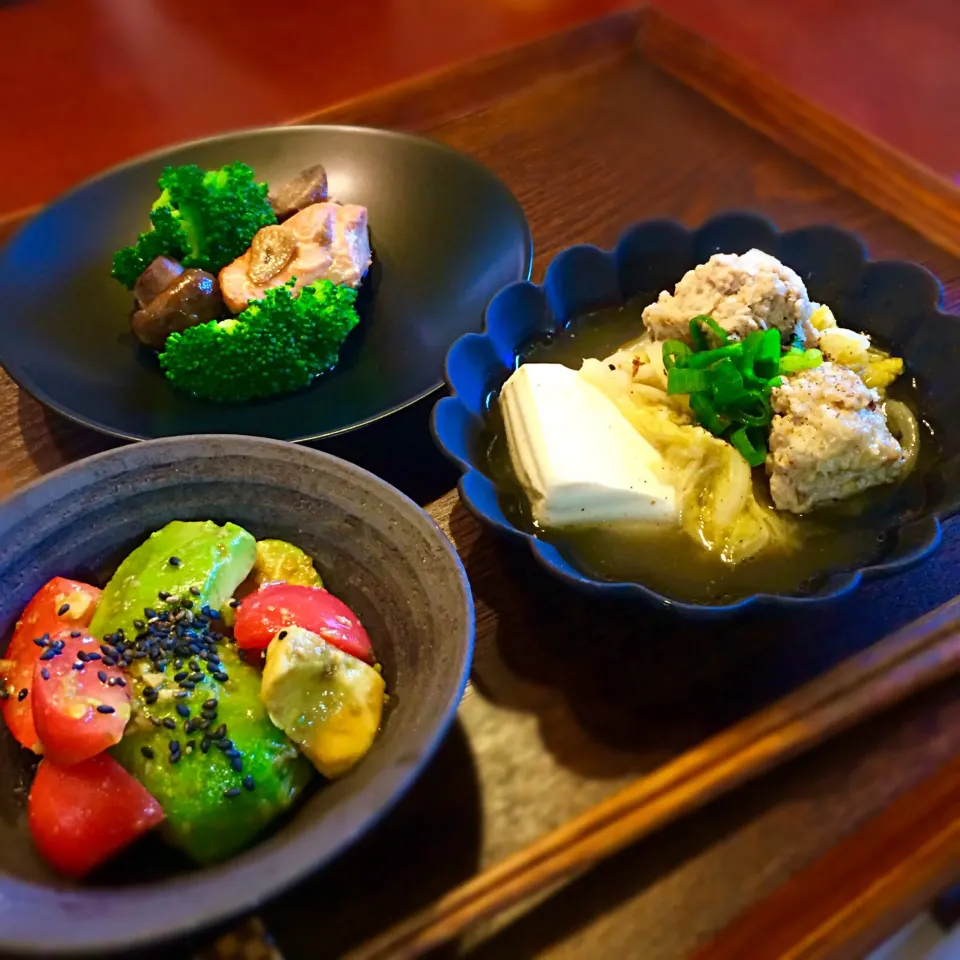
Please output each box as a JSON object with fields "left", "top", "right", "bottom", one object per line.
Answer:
{"left": 637, "top": 8, "right": 960, "bottom": 256}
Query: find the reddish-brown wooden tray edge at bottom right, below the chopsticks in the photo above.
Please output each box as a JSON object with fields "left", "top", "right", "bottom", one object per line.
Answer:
{"left": 691, "top": 757, "right": 960, "bottom": 960}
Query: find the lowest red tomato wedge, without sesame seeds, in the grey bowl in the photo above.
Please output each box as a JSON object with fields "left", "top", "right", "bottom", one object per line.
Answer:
{"left": 29, "top": 753, "right": 163, "bottom": 877}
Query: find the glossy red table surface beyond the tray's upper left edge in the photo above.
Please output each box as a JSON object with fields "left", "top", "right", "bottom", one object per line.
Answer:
{"left": 0, "top": 0, "right": 633, "bottom": 215}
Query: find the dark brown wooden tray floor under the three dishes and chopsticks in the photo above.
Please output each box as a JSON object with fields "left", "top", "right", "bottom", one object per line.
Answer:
{"left": 0, "top": 14, "right": 960, "bottom": 960}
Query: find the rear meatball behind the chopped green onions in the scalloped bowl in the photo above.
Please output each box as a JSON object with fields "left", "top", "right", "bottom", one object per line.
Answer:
{"left": 643, "top": 250, "right": 817, "bottom": 346}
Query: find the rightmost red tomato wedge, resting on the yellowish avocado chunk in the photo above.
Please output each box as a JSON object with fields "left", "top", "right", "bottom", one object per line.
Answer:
{"left": 233, "top": 583, "right": 374, "bottom": 663}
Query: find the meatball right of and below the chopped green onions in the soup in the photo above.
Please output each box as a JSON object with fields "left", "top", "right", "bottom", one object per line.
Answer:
{"left": 767, "top": 363, "right": 906, "bottom": 513}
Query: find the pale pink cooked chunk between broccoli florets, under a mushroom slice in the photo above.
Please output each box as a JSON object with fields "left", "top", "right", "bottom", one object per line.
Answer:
{"left": 220, "top": 202, "right": 371, "bottom": 313}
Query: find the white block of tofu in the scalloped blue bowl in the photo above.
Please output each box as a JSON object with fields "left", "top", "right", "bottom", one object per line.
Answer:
{"left": 500, "top": 363, "right": 679, "bottom": 528}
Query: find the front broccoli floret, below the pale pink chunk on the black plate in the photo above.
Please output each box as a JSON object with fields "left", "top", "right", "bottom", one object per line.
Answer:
{"left": 160, "top": 280, "right": 359, "bottom": 402}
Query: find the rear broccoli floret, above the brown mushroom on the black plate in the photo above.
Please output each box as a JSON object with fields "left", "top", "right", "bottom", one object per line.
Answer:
{"left": 112, "top": 163, "right": 277, "bottom": 289}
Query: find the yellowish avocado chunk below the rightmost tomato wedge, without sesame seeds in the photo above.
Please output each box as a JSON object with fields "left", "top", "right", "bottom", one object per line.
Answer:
{"left": 260, "top": 627, "right": 385, "bottom": 779}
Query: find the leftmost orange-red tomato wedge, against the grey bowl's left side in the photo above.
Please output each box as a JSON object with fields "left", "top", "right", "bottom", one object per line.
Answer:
{"left": 3, "top": 577, "right": 101, "bottom": 753}
